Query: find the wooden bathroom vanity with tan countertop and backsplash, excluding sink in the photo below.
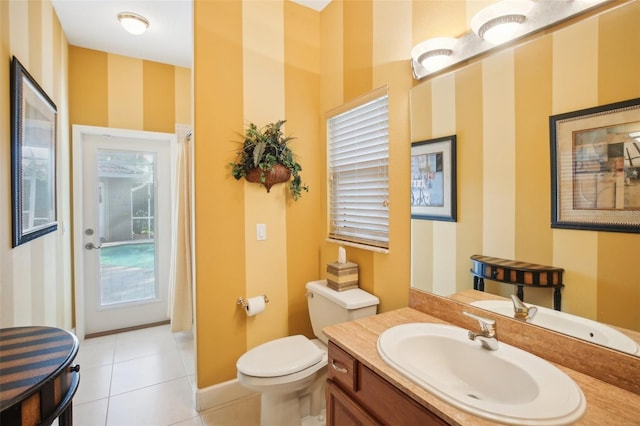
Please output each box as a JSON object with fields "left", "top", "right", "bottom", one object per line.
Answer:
{"left": 324, "top": 289, "right": 640, "bottom": 426}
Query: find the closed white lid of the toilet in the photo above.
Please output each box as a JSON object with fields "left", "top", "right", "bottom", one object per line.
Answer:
{"left": 236, "top": 335, "right": 322, "bottom": 377}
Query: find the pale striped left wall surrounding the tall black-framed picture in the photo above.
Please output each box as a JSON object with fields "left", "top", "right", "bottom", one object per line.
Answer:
{"left": 0, "top": 1, "right": 73, "bottom": 329}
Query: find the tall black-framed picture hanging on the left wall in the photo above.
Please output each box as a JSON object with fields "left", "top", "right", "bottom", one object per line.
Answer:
{"left": 11, "top": 56, "right": 58, "bottom": 247}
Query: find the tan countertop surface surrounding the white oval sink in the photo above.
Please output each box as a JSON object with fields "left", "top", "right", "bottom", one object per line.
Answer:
{"left": 324, "top": 308, "right": 640, "bottom": 426}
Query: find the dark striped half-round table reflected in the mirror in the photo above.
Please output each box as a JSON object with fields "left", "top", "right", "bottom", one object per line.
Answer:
{"left": 471, "top": 254, "right": 564, "bottom": 311}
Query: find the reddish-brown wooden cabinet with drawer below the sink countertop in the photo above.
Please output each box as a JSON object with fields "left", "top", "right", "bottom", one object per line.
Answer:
{"left": 327, "top": 341, "right": 447, "bottom": 426}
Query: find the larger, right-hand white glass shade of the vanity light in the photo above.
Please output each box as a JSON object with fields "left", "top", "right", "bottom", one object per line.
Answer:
{"left": 471, "top": 0, "right": 534, "bottom": 45}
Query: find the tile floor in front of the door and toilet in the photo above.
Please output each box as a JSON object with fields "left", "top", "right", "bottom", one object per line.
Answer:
{"left": 73, "top": 325, "right": 260, "bottom": 426}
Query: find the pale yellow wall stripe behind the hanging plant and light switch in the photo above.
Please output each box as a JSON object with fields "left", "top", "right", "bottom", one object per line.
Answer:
{"left": 241, "top": 2, "right": 290, "bottom": 347}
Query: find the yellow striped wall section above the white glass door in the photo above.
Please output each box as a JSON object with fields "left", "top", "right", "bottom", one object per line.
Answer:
{"left": 69, "top": 46, "right": 191, "bottom": 133}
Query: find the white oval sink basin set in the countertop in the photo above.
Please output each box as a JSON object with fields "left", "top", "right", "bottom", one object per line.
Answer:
{"left": 378, "top": 323, "right": 586, "bottom": 425}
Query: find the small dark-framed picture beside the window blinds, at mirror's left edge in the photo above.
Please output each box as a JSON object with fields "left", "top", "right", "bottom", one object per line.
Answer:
{"left": 411, "top": 135, "right": 456, "bottom": 222}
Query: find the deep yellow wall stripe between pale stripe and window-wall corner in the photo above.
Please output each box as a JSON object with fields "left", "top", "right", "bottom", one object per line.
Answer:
{"left": 284, "top": 2, "right": 324, "bottom": 335}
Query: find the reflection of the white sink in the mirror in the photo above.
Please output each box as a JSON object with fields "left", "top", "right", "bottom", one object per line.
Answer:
{"left": 471, "top": 300, "right": 640, "bottom": 354}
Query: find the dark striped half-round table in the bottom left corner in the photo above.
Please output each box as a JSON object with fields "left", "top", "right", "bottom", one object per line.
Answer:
{"left": 0, "top": 327, "right": 80, "bottom": 426}
